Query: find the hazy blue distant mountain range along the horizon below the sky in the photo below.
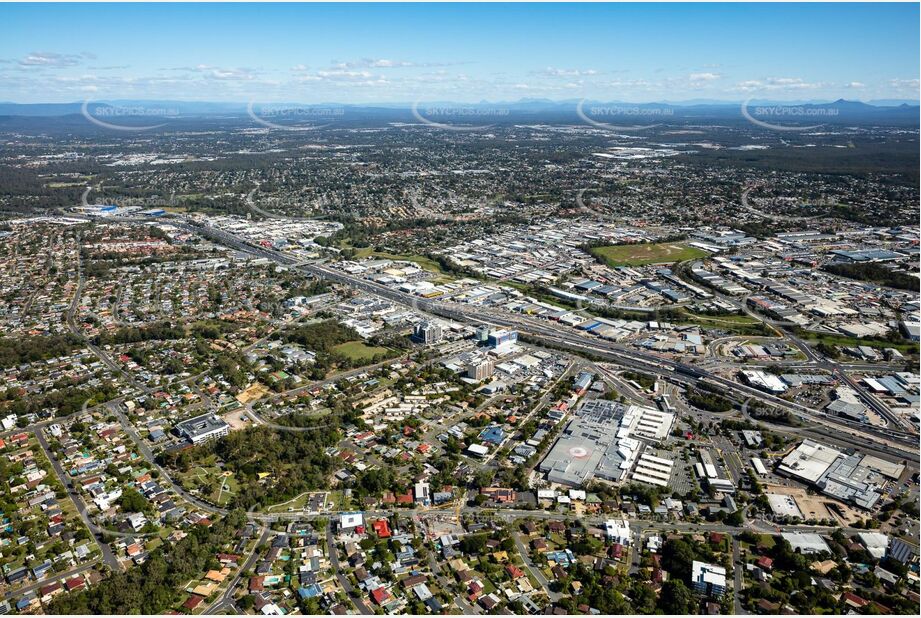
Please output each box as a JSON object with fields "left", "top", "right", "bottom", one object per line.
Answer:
{"left": 0, "top": 99, "right": 921, "bottom": 130}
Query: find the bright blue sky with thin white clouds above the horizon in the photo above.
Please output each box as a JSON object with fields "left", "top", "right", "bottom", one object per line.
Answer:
{"left": 0, "top": 3, "right": 921, "bottom": 103}
